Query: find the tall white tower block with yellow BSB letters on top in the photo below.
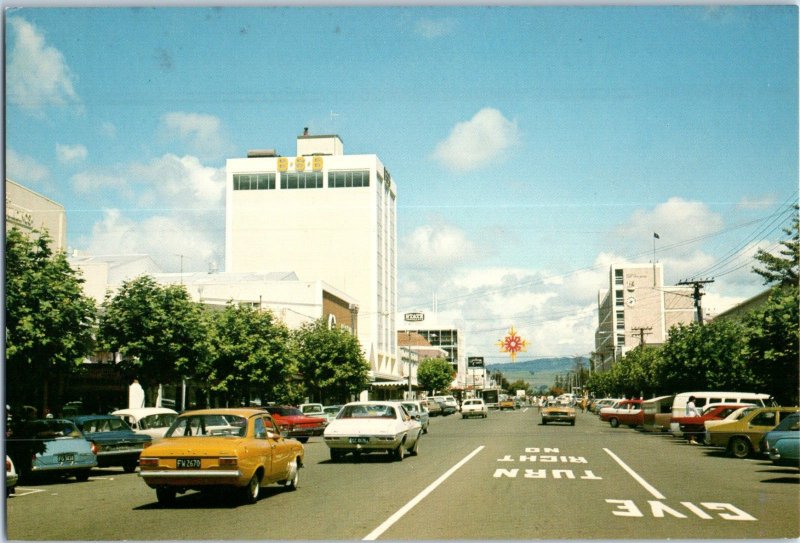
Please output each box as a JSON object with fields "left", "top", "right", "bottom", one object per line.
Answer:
{"left": 225, "top": 134, "right": 403, "bottom": 381}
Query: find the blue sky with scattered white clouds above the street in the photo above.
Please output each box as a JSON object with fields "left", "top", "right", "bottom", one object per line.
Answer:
{"left": 4, "top": 6, "right": 798, "bottom": 362}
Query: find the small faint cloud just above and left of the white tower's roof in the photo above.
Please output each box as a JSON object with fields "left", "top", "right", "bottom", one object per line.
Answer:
{"left": 161, "top": 112, "right": 232, "bottom": 159}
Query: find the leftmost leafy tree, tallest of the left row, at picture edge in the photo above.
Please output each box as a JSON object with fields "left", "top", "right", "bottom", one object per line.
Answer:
{"left": 5, "top": 228, "right": 96, "bottom": 412}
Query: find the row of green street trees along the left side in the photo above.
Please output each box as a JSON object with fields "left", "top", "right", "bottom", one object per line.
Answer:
{"left": 5, "top": 229, "right": 369, "bottom": 410}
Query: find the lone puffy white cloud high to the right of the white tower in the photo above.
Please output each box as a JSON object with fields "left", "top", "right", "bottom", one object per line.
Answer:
{"left": 433, "top": 108, "right": 520, "bottom": 171}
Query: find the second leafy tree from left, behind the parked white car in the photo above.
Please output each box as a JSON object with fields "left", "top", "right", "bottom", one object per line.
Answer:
{"left": 99, "top": 276, "right": 208, "bottom": 402}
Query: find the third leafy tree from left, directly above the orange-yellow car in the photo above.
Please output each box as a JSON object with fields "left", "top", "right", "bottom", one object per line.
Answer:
{"left": 198, "top": 303, "right": 300, "bottom": 405}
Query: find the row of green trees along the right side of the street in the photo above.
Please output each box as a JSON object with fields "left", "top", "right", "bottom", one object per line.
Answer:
{"left": 588, "top": 216, "right": 800, "bottom": 405}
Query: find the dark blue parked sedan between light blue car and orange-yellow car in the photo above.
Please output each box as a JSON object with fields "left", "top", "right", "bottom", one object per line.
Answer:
{"left": 72, "top": 415, "right": 153, "bottom": 473}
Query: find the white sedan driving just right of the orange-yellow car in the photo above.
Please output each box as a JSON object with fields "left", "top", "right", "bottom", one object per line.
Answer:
{"left": 323, "top": 401, "right": 422, "bottom": 462}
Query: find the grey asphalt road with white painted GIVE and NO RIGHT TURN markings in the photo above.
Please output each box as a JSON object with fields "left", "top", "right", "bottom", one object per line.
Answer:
{"left": 5, "top": 408, "right": 800, "bottom": 540}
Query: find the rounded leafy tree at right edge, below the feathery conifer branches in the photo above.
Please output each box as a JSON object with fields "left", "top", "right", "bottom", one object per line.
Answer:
{"left": 744, "top": 285, "right": 800, "bottom": 405}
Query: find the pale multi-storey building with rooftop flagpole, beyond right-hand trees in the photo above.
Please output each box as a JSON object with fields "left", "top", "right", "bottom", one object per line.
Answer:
{"left": 595, "top": 264, "right": 695, "bottom": 371}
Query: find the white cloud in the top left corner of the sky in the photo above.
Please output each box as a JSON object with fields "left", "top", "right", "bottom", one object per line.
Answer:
{"left": 6, "top": 17, "right": 80, "bottom": 115}
